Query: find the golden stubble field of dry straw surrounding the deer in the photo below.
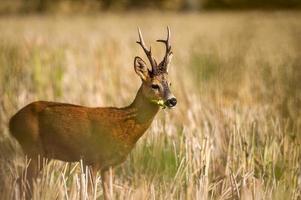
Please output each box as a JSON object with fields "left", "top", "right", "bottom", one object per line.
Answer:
{"left": 0, "top": 11, "right": 301, "bottom": 200}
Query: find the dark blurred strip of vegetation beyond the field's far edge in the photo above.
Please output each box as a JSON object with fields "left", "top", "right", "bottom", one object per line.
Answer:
{"left": 0, "top": 0, "right": 301, "bottom": 14}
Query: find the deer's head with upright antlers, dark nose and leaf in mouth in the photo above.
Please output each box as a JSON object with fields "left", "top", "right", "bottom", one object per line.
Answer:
{"left": 134, "top": 27, "right": 177, "bottom": 108}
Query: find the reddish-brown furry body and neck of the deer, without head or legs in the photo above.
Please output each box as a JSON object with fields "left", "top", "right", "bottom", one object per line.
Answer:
{"left": 9, "top": 86, "right": 159, "bottom": 168}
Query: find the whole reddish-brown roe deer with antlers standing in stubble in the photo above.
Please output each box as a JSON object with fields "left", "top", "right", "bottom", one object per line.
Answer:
{"left": 9, "top": 27, "right": 177, "bottom": 200}
